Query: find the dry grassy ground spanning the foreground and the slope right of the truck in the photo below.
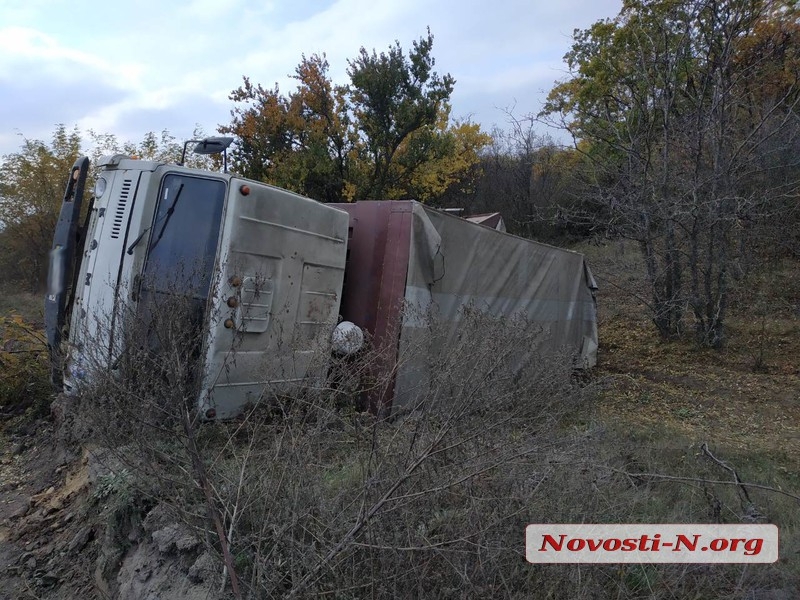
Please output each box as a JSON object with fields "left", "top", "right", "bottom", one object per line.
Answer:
{"left": 1, "top": 244, "right": 800, "bottom": 600}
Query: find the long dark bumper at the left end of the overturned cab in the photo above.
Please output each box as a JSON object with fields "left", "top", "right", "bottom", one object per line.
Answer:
{"left": 44, "top": 156, "right": 89, "bottom": 387}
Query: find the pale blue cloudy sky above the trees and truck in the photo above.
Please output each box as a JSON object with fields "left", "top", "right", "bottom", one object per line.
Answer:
{"left": 0, "top": 0, "right": 622, "bottom": 156}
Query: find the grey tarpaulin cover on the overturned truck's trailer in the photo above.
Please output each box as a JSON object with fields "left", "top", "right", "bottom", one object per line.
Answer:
{"left": 392, "top": 202, "right": 597, "bottom": 412}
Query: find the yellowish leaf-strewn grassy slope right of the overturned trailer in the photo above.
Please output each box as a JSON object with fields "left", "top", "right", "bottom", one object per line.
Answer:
{"left": 582, "top": 237, "right": 800, "bottom": 472}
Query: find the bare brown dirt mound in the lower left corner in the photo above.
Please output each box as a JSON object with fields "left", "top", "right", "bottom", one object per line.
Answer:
{"left": 0, "top": 412, "right": 221, "bottom": 600}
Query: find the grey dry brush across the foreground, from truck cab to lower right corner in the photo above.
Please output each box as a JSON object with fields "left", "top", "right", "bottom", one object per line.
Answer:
{"left": 62, "top": 290, "right": 798, "bottom": 599}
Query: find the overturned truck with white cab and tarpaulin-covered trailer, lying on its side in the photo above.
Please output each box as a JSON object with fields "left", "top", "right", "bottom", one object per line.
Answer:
{"left": 45, "top": 138, "right": 597, "bottom": 419}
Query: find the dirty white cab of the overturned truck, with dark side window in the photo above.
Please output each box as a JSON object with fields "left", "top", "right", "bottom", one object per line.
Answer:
{"left": 50, "top": 143, "right": 349, "bottom": 419}
